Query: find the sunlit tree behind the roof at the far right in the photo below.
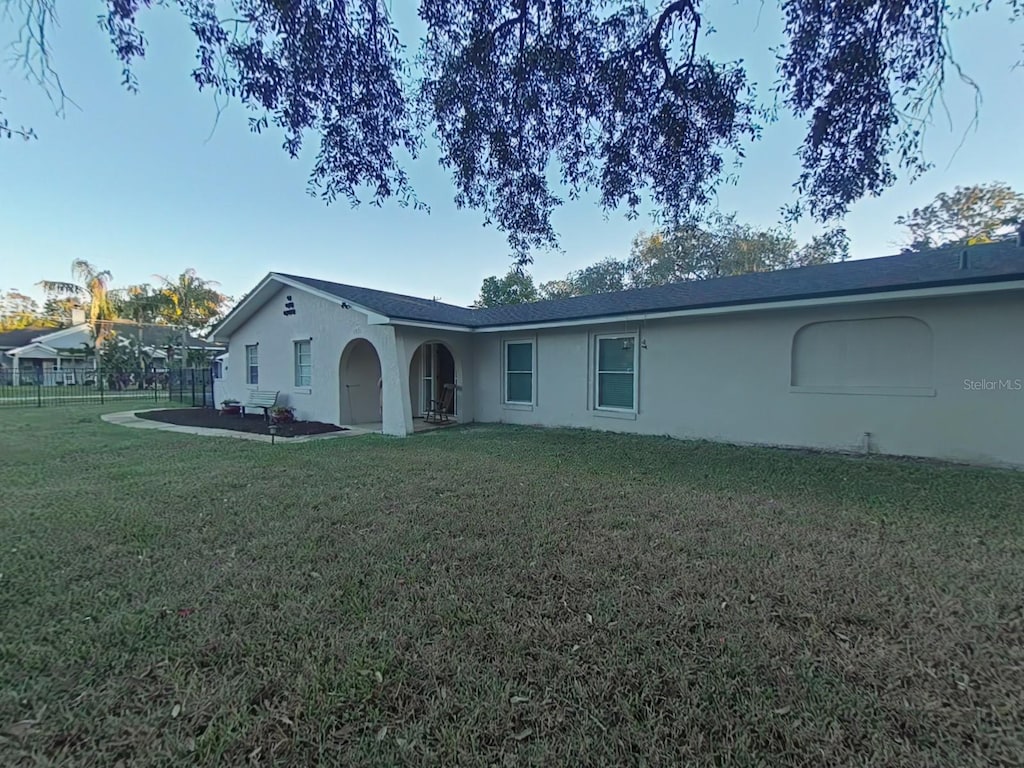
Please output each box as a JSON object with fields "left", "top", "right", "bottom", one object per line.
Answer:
{"left": 896, "top": 181, "right": 1024, "bottom": 251}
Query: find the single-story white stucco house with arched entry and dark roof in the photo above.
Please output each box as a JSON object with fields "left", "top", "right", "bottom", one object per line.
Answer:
{"left": 213, "top": 244, "right": 1024, "bottom": 466}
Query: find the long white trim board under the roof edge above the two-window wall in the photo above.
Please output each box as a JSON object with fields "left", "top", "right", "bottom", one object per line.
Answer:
{"left": 471, "top": 280, "right": 1024, "bottom": 333}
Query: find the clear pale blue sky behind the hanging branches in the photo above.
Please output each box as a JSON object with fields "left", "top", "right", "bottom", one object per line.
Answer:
{"left": 0, "top": 0, "right": 1024, "bottom": 304}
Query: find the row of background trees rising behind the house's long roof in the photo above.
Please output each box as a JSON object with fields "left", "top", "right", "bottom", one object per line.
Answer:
{"left": 475, "top": 181, "right": 1024, "bottom": 307}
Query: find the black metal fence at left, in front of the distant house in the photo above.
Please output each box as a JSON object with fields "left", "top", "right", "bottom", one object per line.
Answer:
{"left": 0, "top": 368, "right": 213, "bottom": 408}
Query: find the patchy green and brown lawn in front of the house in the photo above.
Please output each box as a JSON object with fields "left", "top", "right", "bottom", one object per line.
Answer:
{"left": 0, "top": 406, "right": 1024, "bottom": 766}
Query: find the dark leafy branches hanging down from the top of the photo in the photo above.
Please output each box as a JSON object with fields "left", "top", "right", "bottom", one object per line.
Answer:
{"left": 6, "top": 0, "right": 1024, "bottom": 260}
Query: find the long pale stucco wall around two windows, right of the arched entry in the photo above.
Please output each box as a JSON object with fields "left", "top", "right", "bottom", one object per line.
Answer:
{"left": 472, "top": 293, "right": 1024, "bottom": 466}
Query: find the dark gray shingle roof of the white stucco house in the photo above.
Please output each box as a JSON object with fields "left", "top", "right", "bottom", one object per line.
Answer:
{"left": 282, "top": 241, "right": 1024, "bottom": 328}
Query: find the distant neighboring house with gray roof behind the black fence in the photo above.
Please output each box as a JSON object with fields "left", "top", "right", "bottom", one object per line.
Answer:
{"left": 0, "top": 321, "right": 223, "bottom": 386}
